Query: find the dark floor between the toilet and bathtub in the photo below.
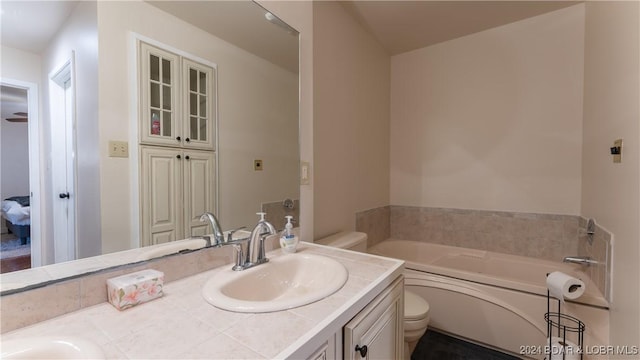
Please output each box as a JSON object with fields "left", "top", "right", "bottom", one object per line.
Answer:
{"left": 411, "top": 330, "right": 520, "bottom": 360}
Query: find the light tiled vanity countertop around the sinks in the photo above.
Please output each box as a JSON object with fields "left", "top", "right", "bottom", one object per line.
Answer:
{"left": 2, "top": 243, "right": 404, "bottom": 359}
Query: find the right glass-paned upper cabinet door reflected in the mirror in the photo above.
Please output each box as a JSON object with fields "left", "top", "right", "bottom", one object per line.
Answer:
{"left": 182, "top": 59, "right": 216, "bottom": 149}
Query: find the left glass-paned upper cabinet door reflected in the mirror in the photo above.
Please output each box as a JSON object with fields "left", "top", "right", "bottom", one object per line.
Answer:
{"left": 139, "top": 42, "right": 182, "bottom": 146}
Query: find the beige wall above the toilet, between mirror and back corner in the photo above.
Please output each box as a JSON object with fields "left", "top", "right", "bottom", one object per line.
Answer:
{"left": 313, "top": 1, "right": 390, "bottom": 238}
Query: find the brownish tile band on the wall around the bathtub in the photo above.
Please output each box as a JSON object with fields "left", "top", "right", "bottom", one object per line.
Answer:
{"left": 356, "top": 205, "right": 612, "bottom": 299}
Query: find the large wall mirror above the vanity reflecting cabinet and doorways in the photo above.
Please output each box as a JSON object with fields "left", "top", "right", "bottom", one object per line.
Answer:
{"left": 0, "top": 1, "right": 300, "bottom": 278}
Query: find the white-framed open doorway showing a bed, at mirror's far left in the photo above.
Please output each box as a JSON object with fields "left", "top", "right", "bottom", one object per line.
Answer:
{"left": 0, "top": 79, "right": 42, "bottom": 272}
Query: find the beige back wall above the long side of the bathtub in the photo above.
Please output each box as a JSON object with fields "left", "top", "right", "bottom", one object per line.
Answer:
{"left": 388, "top": 5, "right": 584, "bottom": 215}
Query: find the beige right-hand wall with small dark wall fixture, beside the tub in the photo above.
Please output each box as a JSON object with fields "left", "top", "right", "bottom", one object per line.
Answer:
{"left": 581, "top": 1, "right": 640, "bottom": 348}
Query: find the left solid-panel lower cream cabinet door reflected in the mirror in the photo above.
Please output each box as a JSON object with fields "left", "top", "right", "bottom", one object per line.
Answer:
{"left": 140, "top": 146, "right": 184, "bottom": 246}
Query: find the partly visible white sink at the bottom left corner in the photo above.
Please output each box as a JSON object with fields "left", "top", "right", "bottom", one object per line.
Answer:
{"left": 0, "top": 336, "right": 105, "bottom": 359}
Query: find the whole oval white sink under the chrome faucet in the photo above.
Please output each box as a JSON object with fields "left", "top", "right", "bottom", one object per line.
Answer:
{"left": 202, "top": 253, "right": 348, "bottom": 313}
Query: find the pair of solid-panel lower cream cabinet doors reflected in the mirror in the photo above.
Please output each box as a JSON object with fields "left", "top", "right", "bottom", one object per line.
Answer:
{"left": 140, "top": 146, "right": 216, "bottom": 246}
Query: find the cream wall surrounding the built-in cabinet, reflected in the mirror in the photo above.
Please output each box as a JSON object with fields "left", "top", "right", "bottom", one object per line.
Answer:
{"left": 98, "top": 2, "right": 299, "bottom": 253}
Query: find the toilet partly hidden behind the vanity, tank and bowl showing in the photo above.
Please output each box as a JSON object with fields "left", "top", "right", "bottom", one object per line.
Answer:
{"left": 315, "top": 231, "right": 429, "bottom": 359}
